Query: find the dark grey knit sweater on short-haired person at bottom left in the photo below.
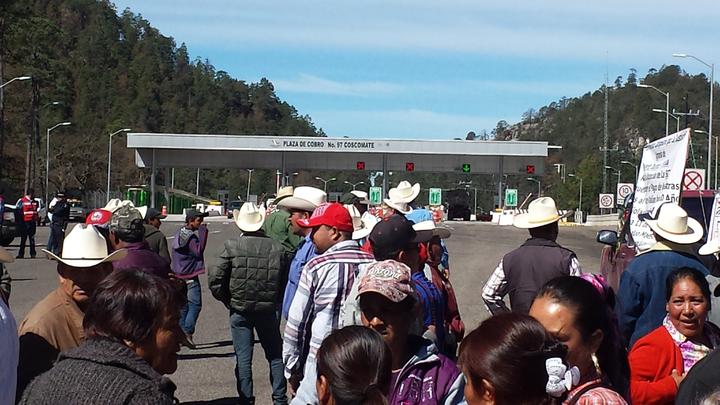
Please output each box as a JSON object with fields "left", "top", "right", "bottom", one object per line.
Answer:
{"left": 20, "top": 338, "right": 176, "bottom": 405}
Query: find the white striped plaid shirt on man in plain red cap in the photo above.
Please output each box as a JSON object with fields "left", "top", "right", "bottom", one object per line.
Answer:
{"left": 283, "top": 240, "right": 375, "bottom": 378}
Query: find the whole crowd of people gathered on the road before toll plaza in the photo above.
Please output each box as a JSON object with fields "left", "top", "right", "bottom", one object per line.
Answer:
{"left": 0, "top": 181, "right": 720, "bottom": 405}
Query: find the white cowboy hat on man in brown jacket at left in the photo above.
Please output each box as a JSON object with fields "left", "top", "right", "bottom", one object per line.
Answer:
{"left": 42, "top": 224, "right": 127, "bottom": 267}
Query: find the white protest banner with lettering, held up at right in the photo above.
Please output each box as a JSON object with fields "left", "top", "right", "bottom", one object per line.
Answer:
{"left": 630, "top": 128, "right": 690, "bottom": 251}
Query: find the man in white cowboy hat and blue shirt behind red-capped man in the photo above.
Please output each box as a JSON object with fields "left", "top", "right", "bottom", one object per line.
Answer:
{"left": 278, "top": 186, "right": 327, "bottom": 319}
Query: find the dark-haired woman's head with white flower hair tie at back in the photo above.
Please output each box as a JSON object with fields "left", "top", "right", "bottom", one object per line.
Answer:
{"left": 459, "top": 312, "right": 579, "bottom": 405}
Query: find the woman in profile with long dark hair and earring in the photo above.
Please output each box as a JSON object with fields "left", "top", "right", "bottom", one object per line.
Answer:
{"left": 530, "top": 275, "right": 630, "bottom": 405}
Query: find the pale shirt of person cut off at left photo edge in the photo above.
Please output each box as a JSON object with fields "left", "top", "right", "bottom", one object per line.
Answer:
{"left": 0, "top": 299, "right": 20, "bottom": 405}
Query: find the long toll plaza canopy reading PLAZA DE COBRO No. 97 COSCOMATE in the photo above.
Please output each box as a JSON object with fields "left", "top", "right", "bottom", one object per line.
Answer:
{"left": 127, "top": 133, "right": 548, "bottom": 205}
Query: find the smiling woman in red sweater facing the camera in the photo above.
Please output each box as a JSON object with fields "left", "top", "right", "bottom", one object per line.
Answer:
{"left": 629, "top": 267, "right": 720, "bottom": 404}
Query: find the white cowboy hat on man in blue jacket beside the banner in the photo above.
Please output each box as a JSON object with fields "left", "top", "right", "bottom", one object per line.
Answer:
{"left": 640, "top": 203, "right": 705, "bottom": 245}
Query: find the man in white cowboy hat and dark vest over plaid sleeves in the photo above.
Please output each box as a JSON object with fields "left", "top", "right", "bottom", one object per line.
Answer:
{"left": 482, "top": 197, "right": 582, "bottom": 314}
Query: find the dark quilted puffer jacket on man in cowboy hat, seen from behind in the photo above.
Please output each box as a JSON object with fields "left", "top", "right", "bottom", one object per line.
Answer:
{"left": 208, "top": 231, "right": 285, "bottom": 312}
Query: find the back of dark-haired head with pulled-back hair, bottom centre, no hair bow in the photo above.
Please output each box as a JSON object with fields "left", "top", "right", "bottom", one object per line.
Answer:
{"left": 316, "top": 325, "right": 392, "bottom": 405}
